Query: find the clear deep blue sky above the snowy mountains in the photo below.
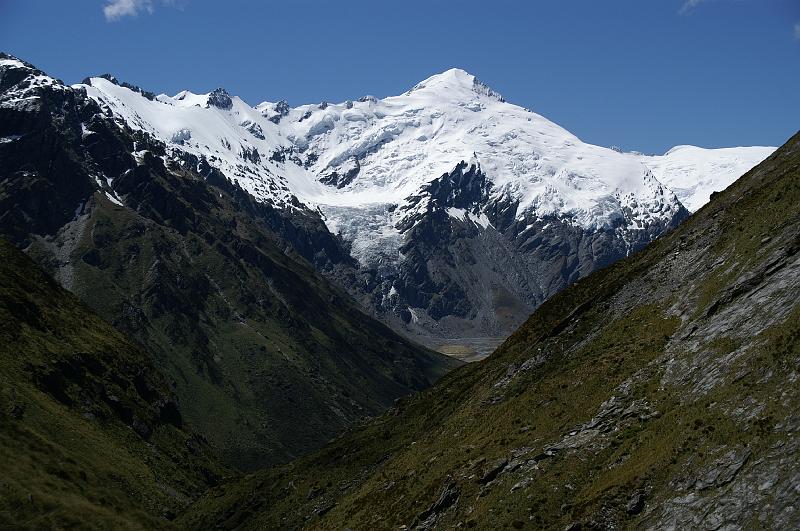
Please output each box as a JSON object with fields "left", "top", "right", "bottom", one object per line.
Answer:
{"left": 0, "top": 0, "right": 800, "bottom": 153}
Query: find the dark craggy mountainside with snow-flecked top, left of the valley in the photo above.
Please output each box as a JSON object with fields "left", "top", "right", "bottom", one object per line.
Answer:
{"left": 0, "top": 56, "right": 457, "bottom": 468}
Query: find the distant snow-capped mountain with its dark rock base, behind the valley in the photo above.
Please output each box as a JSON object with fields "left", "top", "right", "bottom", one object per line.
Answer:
{"left": 78, "top": 64, "right": 774, "bottom": 348}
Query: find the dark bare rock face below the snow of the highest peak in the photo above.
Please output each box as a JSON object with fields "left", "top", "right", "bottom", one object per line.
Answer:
{"left": 362, "top": 161, "right": 689, "bottom": 337}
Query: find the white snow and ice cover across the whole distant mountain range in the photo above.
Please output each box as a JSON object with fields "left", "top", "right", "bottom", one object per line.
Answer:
{"left": 73, "top": 69, "right": 774, "bottom": 261}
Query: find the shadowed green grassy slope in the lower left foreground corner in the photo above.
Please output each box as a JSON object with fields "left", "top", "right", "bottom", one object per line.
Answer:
{"left": 0, "top": 240, "right": 224, "bottom": 529}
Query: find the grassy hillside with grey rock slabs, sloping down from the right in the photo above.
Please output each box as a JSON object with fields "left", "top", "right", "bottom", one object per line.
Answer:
{"left": 184, "top": 134, "right": 800, "bottom": 530}
